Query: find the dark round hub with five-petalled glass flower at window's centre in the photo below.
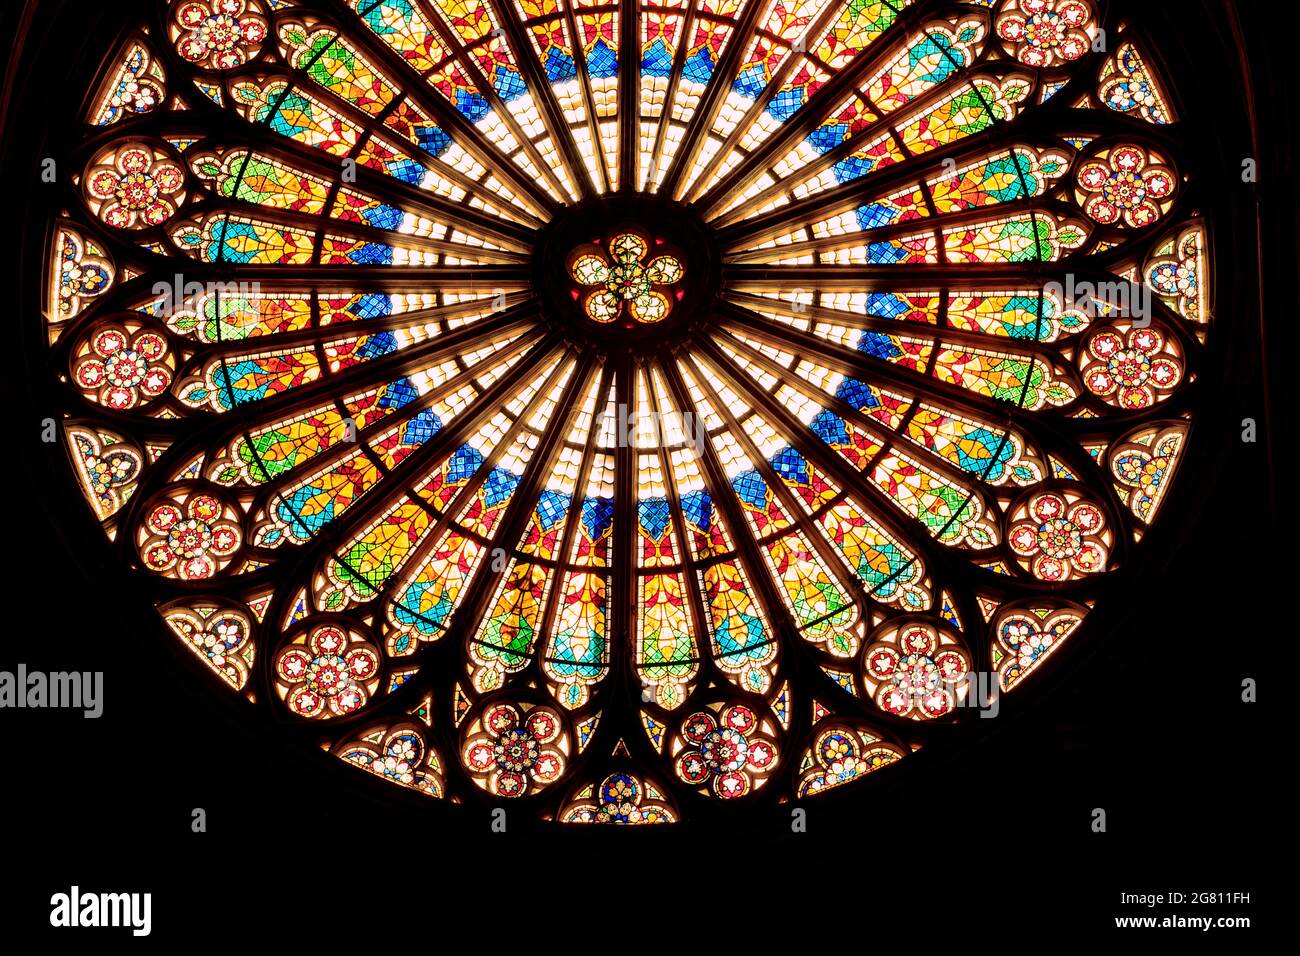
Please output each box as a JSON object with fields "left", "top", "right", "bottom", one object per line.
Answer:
{"left": 534, "top": 195, "right": 719, "bottom": 346}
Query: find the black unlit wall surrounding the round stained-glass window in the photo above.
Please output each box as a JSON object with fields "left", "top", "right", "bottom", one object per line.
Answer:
{"left": 0, "top": 0, "right": 1279, "bottom": 947}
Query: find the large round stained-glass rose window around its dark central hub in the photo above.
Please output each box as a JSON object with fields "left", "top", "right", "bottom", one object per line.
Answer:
{"left": 44, "top": 0, "right": 1210, "bottom": 823}
